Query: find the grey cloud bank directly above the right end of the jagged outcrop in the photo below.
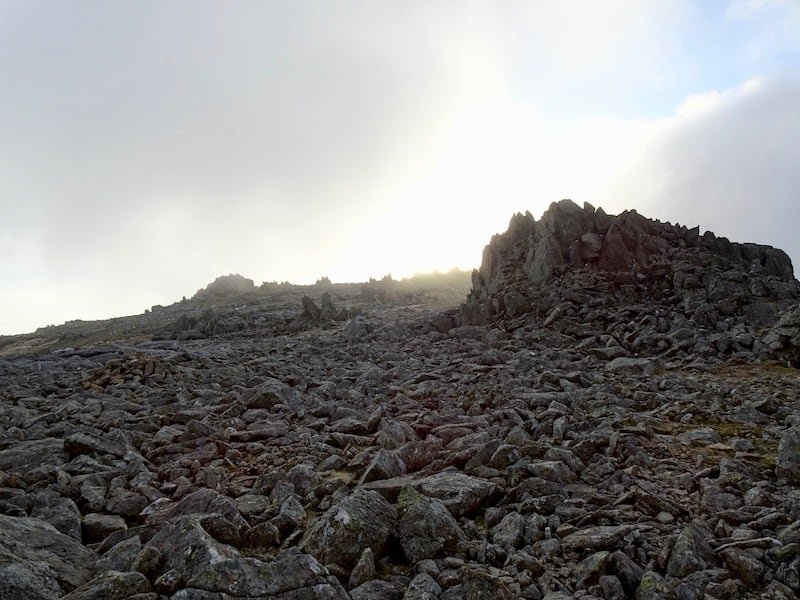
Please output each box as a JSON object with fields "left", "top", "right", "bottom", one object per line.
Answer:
{"left": 604, "top": 76, "right": 800, "bottom": 268}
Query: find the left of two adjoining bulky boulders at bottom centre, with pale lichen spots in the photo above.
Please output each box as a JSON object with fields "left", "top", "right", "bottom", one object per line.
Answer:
{"left": 300, "top": 489, "right": 397, "bottom": 567}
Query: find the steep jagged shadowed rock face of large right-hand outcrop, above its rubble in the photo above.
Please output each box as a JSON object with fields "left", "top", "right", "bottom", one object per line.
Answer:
{"left": 461, "top": 200, "right": 800, "bottom": 340}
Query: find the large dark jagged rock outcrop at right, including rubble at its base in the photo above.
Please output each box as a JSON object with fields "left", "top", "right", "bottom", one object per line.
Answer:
{"left": 461, "top": 200, "right": 800, "bottom": 358}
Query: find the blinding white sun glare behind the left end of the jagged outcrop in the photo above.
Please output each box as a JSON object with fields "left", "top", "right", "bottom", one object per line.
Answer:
{"left": 332, "top": 102, "right": 646, "bottom": 281}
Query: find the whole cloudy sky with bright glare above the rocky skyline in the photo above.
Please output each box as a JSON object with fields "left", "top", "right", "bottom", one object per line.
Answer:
{"left": 0, "top": 0, "right": 800, "bottom": 334}
